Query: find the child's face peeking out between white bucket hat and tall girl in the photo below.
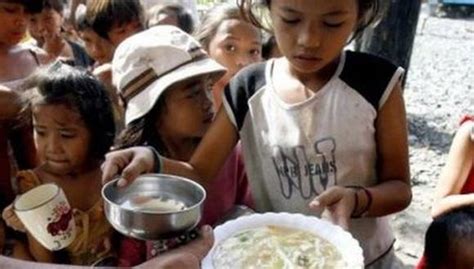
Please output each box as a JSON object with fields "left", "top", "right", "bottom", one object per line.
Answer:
{"left": 208, "top": 19, "right": 262, "bottom": 81}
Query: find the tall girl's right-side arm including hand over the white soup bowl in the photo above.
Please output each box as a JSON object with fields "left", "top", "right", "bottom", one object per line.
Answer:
{"left": 310, "top": 83, "right": 411, "bottom": 228}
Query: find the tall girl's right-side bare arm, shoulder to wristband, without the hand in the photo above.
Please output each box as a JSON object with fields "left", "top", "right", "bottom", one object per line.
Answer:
{"left": 359, "top": 83, "right": 412, "bottom": 217}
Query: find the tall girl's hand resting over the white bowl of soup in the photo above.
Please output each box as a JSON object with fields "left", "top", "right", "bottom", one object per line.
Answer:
{"left": 309, "top": 186, "right": 355, "bottom": 230}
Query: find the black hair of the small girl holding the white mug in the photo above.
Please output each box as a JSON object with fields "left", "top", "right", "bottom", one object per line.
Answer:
{"left": 26, "top": 61, "right": 115, "bottom": 160}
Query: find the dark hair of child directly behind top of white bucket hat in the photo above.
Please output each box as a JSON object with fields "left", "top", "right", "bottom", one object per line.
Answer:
{"left": 148, "top": 4, "right": 194, "bottom": 34}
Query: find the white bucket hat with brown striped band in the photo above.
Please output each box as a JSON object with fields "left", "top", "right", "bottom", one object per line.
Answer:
{"left": 112, "top": 25, "right": 226, "bottom": 125}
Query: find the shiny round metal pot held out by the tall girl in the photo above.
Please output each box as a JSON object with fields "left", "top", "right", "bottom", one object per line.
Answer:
{"left": 102, "top": 174, "right": 206, "bottom": 240}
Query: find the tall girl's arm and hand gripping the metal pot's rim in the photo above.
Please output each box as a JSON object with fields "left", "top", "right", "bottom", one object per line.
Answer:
{"left": 102, "top": 108, "right": 238, "bottom": 186}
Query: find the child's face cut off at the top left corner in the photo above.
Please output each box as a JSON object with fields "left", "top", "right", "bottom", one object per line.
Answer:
{"left": 0, "top": 2, "right": 28, "bottom": 46}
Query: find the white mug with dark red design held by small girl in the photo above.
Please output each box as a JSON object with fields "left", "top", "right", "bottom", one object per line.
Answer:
{"left": 13, "top": 183, "right": 76, "bottom": 251}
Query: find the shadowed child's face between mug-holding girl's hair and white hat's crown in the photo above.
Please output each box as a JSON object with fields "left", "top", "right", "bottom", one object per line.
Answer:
{"left": 80, "top": 29, "right": 114, "bottom": 65}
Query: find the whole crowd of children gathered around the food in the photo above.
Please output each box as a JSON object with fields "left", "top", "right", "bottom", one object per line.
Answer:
{"left": 0, "top": 0, "right": 474, "bottom": 268}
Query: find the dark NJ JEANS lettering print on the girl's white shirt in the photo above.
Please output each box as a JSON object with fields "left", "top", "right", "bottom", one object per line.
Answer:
{"left": 272, "top": 137, "right": 337, "bottom": 200}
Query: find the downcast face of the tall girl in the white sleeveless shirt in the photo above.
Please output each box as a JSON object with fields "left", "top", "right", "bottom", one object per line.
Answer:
{"left": 270, "top": 0, "right": 358, "bottom": 74}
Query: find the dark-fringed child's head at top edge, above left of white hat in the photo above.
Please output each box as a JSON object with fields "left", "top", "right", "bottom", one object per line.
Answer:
{"left": 86, "top": 0, "right": 145, "bottom": 47}
